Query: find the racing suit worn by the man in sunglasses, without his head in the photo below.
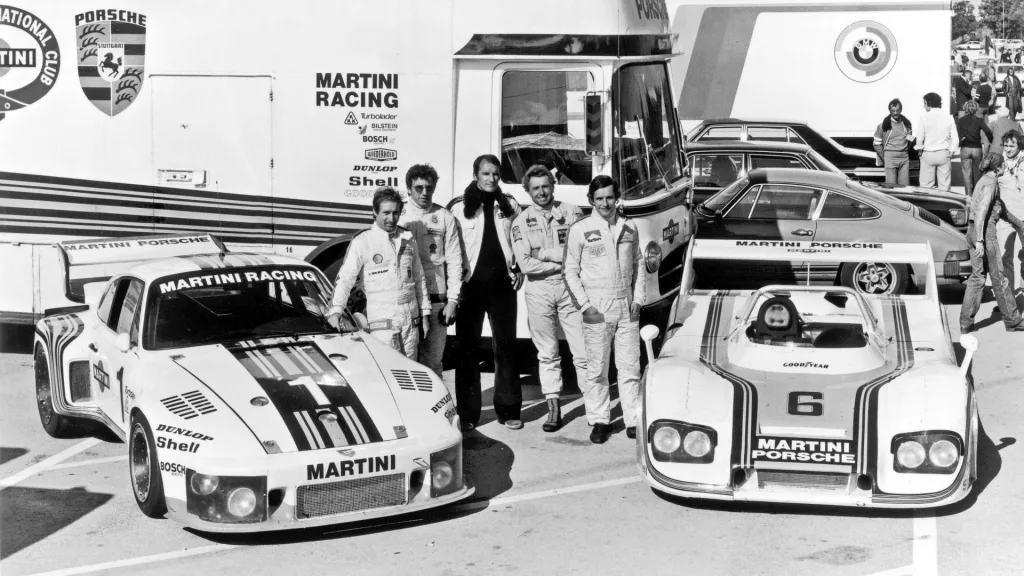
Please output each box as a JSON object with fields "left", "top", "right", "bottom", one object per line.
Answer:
{"left": 398, "top": 202, "right": 462, "bottom": 377}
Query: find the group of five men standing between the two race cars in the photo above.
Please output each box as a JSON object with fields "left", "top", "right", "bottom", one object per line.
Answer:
{"left": 328, "top": 154, "right": 646, "bottom": 444}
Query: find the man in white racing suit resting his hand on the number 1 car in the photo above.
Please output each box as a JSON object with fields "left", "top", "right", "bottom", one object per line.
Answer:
{"left": 328, "top": 188, "right": 430, "bottom": 361}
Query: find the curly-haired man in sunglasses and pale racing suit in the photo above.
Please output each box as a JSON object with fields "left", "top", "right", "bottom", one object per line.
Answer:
{"left": 398, "top": 164, "right": 462, "bottom": 377}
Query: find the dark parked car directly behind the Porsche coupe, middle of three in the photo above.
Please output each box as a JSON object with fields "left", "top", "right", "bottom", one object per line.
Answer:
{"left": 686, "top": 140, "right": 968, "bottom": 233}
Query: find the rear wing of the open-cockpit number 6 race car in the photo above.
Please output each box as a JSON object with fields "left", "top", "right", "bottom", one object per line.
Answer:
{"left": 682, "top": 239, "right": 937, "bottom": 297}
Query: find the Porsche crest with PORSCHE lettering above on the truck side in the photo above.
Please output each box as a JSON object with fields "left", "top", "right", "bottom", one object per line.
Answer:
{"left": 75, "top": 9, "right": 145, "bottom": 116}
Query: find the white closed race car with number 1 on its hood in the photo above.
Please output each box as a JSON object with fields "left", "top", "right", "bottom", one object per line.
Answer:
{"left": 34, "top": 231, "right": 473, "bottom": 532}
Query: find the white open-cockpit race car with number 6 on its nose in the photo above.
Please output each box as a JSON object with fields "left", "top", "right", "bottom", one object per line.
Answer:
{"left": 637, "top": 240, "right": 978, "bottom": 507}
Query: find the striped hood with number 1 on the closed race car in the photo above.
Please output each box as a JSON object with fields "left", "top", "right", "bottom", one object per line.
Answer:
{"left": 169, "top": 335, "right": 404, "bottom": 453}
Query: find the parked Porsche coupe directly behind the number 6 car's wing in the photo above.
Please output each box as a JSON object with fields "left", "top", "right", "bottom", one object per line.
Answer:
{"left": 696, "top": 168, "right": 971, "bottom": 294}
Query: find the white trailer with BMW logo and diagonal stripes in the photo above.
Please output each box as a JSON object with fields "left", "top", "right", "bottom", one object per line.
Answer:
{"left": 667, "top": 0, "right": 952, "bottom": 150}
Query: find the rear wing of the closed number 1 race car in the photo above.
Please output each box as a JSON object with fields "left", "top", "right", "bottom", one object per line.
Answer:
{"left": 56, "top": 234, "right": 227, "bottom": 302}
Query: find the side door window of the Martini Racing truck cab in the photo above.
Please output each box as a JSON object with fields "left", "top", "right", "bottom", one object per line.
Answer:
{"left": 502, "top": 70, "right": 594, "bottom": 184}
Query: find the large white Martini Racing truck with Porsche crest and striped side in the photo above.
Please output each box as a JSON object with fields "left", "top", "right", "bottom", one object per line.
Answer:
{"left": 0, "top": 0, "right": 692, "bottom": 335}
